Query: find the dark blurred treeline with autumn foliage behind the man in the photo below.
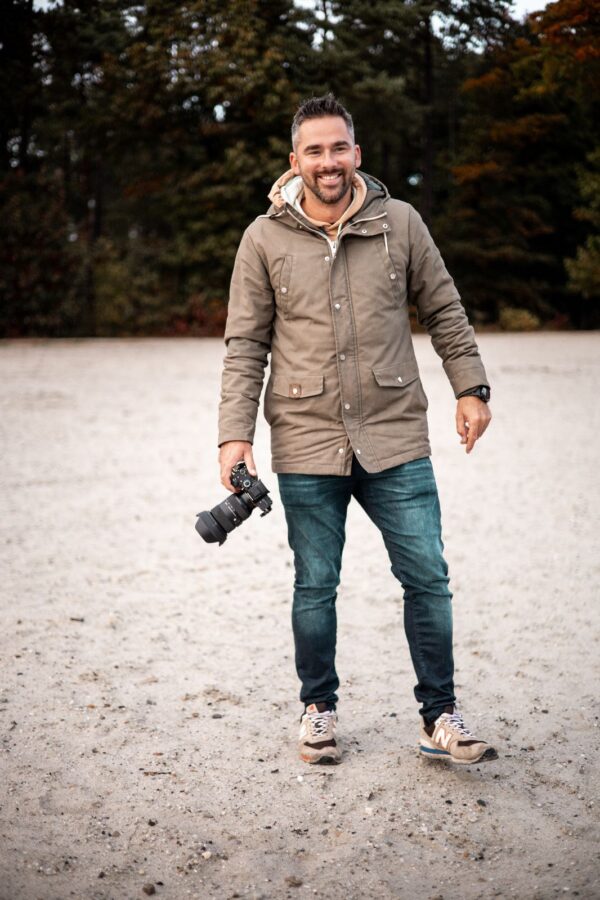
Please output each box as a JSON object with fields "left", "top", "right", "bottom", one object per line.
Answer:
{"left": 0, "top": 0, "right": 600, "bottom": 336}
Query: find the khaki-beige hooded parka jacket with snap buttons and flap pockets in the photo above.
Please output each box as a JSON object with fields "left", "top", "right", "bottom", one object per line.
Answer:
{"left": 219, "top": 172, "right": 489, "bottom": 475}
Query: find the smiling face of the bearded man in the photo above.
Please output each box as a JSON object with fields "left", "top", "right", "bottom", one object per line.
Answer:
{"left": 290, "top": 116, "right": 361, "bottom": 204}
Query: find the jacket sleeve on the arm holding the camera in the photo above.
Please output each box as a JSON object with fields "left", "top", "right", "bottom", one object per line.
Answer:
{"left": 219, "top": 230, "right": 275, "bottom": 446}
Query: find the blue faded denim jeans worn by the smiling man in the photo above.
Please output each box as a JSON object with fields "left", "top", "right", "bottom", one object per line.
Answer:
{"left": 277, "top": 457, "right": 456, "bottom": 723}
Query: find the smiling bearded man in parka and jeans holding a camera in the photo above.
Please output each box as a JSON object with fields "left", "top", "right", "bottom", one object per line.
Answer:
{"left": 219, "top": 94, "right": 497, "bottom": 764}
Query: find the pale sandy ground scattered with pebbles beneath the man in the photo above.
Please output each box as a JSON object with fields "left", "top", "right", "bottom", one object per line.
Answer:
{"left": 0, "top": 333, "right": 600, "bottom": 900}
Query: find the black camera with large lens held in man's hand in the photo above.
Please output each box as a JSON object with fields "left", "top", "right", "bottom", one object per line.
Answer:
{"left": 196, "top": 462, "right": 273, "bottom": 546}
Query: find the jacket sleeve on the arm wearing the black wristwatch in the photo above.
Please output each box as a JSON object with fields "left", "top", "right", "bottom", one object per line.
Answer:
{"left": 407, "top": 206, "right": 489, "bottom": 397}
